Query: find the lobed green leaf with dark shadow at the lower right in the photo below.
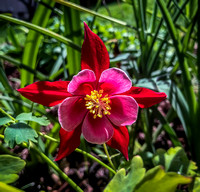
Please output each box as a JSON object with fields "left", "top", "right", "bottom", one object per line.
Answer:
{"left": 153, "top": 147, "right": 197, "bottom": 175}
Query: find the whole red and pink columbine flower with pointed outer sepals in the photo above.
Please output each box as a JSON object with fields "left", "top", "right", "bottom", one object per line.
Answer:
{"left": 18, "top": 23, "right": 166, "bottom": 160}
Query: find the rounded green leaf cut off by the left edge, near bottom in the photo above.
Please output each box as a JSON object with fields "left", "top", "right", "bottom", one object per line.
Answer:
{"left": 0, "top": 155, "right": 26, "bottom": 183}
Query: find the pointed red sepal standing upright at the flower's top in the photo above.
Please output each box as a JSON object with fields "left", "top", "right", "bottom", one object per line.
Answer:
{"left": 81, "top": 22, "right": 110, "bottom": 80}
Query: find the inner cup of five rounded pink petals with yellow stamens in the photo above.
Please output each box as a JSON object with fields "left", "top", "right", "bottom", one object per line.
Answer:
{"left": 58, "top": 68, "right": 138, "bottom": 144}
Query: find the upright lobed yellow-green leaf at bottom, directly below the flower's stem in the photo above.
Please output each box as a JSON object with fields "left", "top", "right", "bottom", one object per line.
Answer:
{"left": 104, "top": 156, "right": 145, "bottom": 192}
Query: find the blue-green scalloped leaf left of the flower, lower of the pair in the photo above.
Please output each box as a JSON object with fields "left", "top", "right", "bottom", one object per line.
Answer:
{"left": 4, "top": 123, "right": 38, "bottom": 148}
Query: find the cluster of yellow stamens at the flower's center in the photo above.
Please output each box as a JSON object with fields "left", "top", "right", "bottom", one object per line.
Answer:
{"left": 84, "top": 90, "right": 111, "bottom": 119}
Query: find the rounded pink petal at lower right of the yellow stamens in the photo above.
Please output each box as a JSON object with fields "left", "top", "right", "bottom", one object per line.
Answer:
{"left": 108, "top": 95, "right": 138, "bottom": 126}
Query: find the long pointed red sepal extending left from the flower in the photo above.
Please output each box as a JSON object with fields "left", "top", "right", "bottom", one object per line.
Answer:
{"left": 17, "top": 81, "right": 71, "bottom": 107}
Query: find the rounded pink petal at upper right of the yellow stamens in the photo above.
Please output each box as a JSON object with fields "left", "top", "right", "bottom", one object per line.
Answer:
{"left": 99, "top": 68, "right": 132, "bottom": 95}
